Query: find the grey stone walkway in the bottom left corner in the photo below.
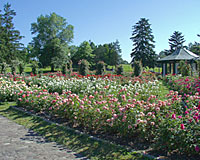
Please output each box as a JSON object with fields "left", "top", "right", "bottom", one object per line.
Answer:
{"left": 0, "top": 115, "right": 87, "bottom": 160}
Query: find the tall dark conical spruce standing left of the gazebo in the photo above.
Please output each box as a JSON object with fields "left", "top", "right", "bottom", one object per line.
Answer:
{"left": 130, "top": 18, "right": 156, "bottom": 67}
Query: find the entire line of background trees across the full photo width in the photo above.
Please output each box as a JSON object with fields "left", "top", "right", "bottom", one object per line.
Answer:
{"left": 0, "top": 3, "right": 200, "bottom": 71}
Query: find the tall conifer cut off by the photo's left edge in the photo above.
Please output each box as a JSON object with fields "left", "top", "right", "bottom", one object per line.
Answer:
{"left": 0, "top": 3, "right": 25, "bottom": 64}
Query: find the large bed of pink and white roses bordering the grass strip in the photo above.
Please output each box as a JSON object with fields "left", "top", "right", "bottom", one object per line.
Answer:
{"left": 0, "top": 76, "right": 200, "bottom": 154}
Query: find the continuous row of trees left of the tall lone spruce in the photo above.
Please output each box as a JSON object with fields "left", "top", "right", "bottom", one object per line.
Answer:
{"left": 0, "top": 3, "right": 128, "bottom": 71}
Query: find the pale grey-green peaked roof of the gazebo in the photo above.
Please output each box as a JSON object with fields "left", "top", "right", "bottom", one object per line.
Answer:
{"left": 157, "top": 48, "right": 199, "bottom": 62}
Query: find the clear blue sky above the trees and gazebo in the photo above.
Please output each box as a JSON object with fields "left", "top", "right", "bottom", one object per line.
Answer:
{"left": 0, "top": 0, "right": 200, "bottom": 62}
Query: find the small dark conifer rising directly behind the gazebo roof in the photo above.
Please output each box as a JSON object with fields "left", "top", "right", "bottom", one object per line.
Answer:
{"left": 168, "top": 31, "right": 185, "bottom": 55}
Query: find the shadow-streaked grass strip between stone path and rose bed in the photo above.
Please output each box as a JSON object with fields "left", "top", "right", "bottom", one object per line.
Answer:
{"left": 0, "top": 102, "right": 152, "bottom": 160}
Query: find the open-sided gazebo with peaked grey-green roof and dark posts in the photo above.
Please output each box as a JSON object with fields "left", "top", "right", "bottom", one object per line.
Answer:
{"left": 157, "top": 48, "right": 199, "bottom": 76}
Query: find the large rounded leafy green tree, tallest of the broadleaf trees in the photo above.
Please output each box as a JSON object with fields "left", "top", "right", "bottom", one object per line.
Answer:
{"left": 31, "top": 13, "right": 74, "bottom": 71}
